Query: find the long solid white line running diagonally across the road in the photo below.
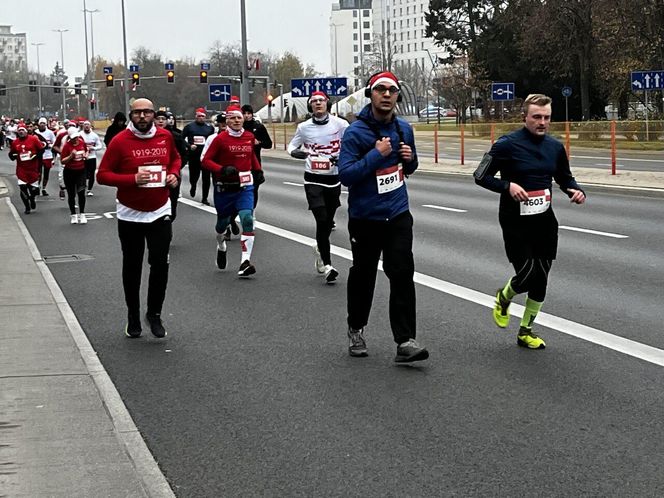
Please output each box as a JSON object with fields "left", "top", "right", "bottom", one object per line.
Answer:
{"left": 180, "top": 198, "right": 664, "bottom": 367}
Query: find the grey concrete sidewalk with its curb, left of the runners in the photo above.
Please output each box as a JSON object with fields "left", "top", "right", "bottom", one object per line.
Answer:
{"left": 0, "top": 178, "right": 174, "bottom": 497}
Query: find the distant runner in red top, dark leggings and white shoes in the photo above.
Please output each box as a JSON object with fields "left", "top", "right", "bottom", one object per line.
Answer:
{"left": 60, "top": 126, "right": 88, "bottom": 225}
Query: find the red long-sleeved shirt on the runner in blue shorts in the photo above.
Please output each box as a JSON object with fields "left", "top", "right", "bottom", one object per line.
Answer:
{"left": 202, "top": 130, "right": 261, "bottom": 182}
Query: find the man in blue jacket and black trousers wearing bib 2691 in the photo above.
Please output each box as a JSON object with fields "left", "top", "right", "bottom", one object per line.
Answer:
{"left": 338, "top": 71, "right": 429, "bottom": 363}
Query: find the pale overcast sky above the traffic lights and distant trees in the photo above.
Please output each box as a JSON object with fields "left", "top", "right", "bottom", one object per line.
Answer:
{"left": 6, "top": 0, "right": 333, "bottom": 77}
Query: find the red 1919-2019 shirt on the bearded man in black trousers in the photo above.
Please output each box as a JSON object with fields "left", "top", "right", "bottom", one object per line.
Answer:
{"left": 97, "top": 128, "right": 181, "bottom": 211}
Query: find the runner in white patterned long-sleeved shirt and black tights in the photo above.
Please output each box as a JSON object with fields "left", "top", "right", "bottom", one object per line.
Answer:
{"left": 288, "top": 92, "right": 348, "bottom": 284}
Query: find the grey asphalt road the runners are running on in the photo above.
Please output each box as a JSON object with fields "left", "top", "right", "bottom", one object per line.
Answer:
{"left": 0, "top": 154, "right": 664, "bottom": 497}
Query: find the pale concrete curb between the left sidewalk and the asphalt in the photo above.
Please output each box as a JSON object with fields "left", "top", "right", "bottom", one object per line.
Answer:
{"left": 0, "top": 196, "right": 175, "bottom": 498}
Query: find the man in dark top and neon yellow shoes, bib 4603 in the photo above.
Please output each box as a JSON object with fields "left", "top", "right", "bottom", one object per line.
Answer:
{"left": 475, "top": 94, "right": 586, "bottom": 349}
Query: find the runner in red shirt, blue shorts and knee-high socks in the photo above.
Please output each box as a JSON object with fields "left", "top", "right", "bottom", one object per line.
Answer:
{"left": 203, "top": 106, "right": 261, "bottom": 277}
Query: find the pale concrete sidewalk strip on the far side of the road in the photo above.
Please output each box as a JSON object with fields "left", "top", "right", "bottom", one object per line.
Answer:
{"left": 261, "top": 148, "right": 664, "bottom": 191}
